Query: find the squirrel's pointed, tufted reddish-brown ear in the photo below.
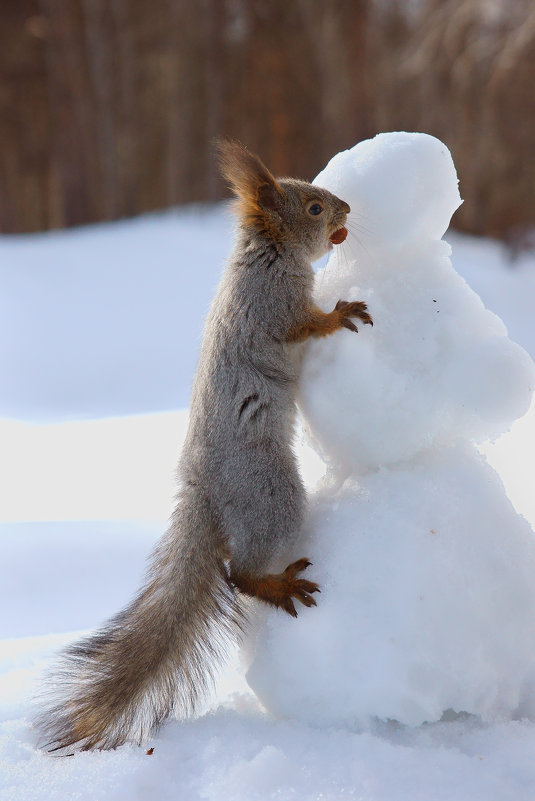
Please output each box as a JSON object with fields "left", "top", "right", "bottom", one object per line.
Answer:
{"left": 217, "top": 140, "right": 283, "bottom": 213}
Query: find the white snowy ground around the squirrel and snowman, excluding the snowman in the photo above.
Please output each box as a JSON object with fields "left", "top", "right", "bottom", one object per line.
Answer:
{"left": 0, "top": 207, "right": 535, "bottom": 801}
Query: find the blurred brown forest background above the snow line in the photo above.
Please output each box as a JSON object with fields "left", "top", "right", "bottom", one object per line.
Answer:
{"left": 0, "top": 0, "right": 535, "bottom": 242}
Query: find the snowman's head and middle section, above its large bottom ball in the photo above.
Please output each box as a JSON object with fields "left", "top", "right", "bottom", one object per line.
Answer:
{"left": 301, "top": 134, "right": 535, "bottom": 466}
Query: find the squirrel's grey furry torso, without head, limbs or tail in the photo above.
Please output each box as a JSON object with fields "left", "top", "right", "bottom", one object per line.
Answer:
{"left": 180, "top": 228, "right": 312, "bottom": 573}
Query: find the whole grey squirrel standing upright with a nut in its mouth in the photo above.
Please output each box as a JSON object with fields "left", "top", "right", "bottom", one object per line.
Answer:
{"left": 37, "top": 141, "right": 373, "bottom": 752}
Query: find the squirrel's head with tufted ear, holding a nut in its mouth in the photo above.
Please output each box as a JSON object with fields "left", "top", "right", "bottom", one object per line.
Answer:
{"left": 218, "top": 141, "right": 350, "bottom": 261}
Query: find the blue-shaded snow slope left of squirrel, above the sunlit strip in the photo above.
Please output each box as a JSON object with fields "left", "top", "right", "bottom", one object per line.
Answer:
{"left": 0, "top": 205, "right": 232, "bottom": 421}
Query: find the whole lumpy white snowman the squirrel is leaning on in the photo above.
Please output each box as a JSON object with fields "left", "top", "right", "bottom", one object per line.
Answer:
{"left": 248, "top": 133, "right": 535, "bottom": 727}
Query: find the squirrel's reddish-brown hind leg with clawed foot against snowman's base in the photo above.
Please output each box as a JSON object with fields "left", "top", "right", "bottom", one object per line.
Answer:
{"left": 230, "top": 559, "right": 320, "bottom": 617}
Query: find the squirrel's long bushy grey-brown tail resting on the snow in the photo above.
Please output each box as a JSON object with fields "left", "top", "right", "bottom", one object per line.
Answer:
{"left": 36, "top": 487, "right": 242, "bottom": 750}
